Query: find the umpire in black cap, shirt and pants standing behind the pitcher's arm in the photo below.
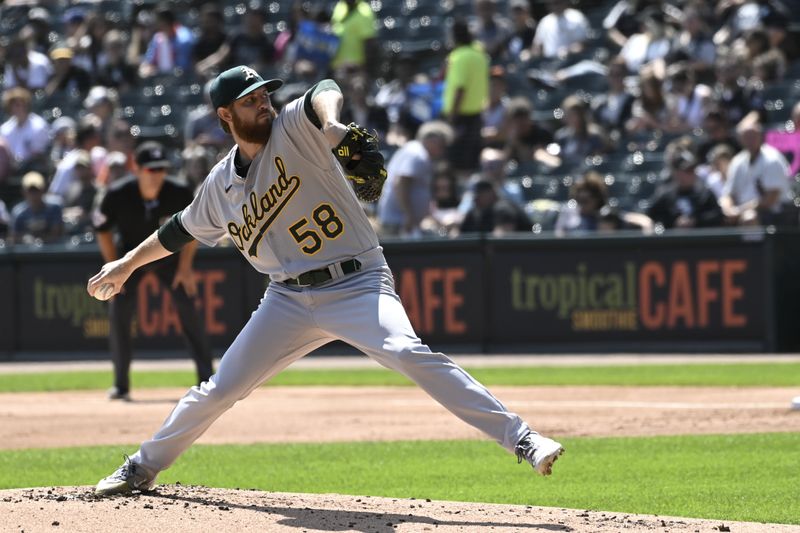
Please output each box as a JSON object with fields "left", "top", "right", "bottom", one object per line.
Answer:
{"left": 94, "top": 142, "right": 213, "bottom": 400}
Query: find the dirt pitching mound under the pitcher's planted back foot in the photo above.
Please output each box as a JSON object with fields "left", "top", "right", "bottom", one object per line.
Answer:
{"left": 0, "top": 485, "right": 798, "bottom": 533}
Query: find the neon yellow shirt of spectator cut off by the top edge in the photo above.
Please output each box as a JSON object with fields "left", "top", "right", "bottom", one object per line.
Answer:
{"left": 331, "top": 0, "right": 376, "bottom": 68}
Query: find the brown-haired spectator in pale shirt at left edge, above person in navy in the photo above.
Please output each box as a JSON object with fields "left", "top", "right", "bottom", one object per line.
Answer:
{"left": 0, "top": 87, "right": 50, "bottom": 170}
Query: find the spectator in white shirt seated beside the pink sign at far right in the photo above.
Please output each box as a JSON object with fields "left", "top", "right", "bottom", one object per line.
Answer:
{"left": 720, "top": 111, "right": 789, "bottom": 225}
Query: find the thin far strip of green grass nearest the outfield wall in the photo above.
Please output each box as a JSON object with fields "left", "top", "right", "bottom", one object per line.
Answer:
{"left": 0, "top": 363, "right": 800, "bottom": 392}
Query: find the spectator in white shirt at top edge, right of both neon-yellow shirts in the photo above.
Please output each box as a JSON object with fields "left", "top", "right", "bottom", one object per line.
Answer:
{"left": 531, "top": 0, "right": 589, "bottom": 58}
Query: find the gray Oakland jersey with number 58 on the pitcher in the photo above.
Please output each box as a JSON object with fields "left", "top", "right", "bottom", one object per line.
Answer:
{"left": 181, "top": 98, "right": 378, "bottom": 281}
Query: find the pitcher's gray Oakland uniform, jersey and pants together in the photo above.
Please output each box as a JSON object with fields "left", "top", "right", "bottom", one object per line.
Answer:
{"left": 123, "top": 81, "right": 552, "bottom": 476}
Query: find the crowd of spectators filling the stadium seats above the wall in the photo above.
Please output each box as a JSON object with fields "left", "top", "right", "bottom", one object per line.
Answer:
{"left": 0, "top": 0, "right": 800, "bottom": 245}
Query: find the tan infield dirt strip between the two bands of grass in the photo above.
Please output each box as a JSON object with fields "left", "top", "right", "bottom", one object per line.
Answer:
{"left": 0, "top": 387, "right": 800, "bottom": 449}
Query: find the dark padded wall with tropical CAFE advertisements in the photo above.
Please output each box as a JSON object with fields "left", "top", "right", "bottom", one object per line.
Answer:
{"left": 0, "top": 229, "right": 800, "bottom": 358}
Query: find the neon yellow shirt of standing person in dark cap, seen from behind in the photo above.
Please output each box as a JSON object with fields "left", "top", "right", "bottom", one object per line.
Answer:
{"left": 443, "top": 42, "right": 489, "bottom": 115}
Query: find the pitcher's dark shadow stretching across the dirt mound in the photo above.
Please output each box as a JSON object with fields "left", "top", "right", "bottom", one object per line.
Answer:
{"left": 147, "top": 489, "right": 573, "bottom": 533}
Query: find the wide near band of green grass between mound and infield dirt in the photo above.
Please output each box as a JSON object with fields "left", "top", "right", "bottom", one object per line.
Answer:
{"left": 0, "top": 433, "right": 800, "bottom": 524}
